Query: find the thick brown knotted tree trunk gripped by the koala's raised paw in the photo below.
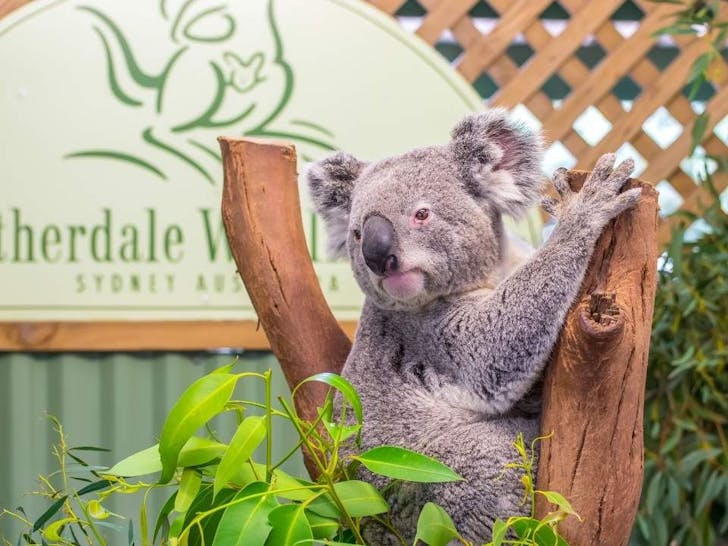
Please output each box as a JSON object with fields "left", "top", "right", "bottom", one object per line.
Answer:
{"left": 537, "top": 172, "right": 657, "bottom": 546}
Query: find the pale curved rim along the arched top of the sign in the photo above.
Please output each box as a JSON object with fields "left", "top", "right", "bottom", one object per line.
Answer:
{"left": 0, "top": 0, "right": 484, "bottom": 111}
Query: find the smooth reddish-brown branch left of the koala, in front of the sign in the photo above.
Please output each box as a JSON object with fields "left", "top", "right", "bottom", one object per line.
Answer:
{"left": 219, "top": 138, "right": 351, "bottom": 444}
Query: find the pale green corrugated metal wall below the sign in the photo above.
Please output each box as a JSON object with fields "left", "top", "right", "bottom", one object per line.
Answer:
{"left": 0, "top": 352, "right": 305, "bottom": 544}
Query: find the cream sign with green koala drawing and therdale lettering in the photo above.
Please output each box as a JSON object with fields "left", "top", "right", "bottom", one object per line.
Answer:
{"left": 0, "top": 0, "right": 490, "bottom": 321}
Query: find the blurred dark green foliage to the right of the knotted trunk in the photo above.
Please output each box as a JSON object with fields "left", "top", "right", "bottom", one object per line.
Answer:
{"left": 631, "top": 181, "right": 728, "bottom": 546}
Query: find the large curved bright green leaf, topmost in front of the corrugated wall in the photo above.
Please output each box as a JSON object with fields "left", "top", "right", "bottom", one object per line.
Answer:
{"left": 159, "top": 373, "right": 238, "bottom": 483}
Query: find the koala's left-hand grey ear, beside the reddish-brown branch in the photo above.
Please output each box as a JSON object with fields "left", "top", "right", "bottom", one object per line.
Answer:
{"left": 306, "top": 152, "right": 366, "bottom": 258}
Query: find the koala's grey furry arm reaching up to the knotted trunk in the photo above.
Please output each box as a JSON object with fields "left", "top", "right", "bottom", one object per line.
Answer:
{"left": 440, "top": 154, "right": 641, "bottom": 414}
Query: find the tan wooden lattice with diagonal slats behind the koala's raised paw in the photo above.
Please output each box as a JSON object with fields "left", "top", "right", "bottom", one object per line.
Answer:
{"left": 369, "top": 0, "right": 728, "bottom": 241}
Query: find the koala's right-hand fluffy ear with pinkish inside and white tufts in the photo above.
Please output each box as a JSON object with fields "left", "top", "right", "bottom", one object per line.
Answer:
{"left": 450, "top": 108, "right": 543, "bottom": 216}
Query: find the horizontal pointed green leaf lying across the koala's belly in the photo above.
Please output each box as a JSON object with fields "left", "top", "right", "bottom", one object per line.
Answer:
{"left": 354, "top": 446, "right": 463, "bottom": 483}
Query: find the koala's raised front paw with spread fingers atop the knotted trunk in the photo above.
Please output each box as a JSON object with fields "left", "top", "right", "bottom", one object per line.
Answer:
{"left": 542, "top": 154, "right": 642, "bottom": 230}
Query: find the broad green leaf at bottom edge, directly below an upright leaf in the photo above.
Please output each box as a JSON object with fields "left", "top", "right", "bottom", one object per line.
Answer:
{"left": 212, "top": 482, "right": 278, "bottom": 546}
